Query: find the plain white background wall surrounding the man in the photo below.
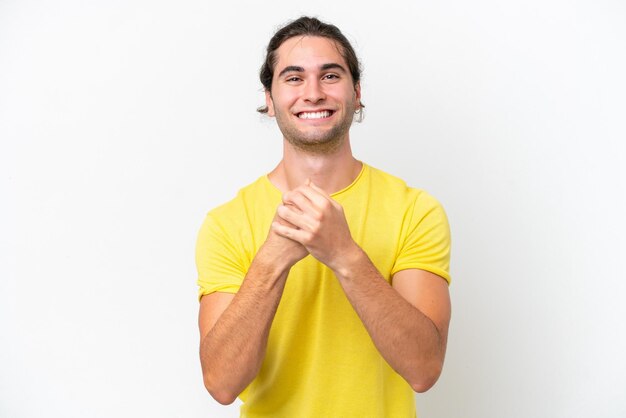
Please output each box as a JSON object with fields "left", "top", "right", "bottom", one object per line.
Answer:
{"left": 0, "top": 0, "right": 626, "bottom": 418}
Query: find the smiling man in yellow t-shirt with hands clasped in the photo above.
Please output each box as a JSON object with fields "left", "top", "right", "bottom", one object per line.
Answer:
{"left": 196, "top": 17, "right": 450, "bottom": 418}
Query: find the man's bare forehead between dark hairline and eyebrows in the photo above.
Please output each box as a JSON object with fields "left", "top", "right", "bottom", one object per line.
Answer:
{"left": 274, "top": 36, "right": 348, "bottom": 74}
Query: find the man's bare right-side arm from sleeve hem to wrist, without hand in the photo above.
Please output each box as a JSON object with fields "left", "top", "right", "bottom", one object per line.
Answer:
{"left": 336, "top": 247, "right": 450, "bottom": 392}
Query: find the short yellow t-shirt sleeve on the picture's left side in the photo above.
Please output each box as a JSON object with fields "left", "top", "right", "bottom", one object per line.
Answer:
{"left": 196, "top": 213, "right": 247, "bottom": 299}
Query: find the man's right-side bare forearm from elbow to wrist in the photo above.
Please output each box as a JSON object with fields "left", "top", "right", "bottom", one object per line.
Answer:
{"left": 334, "top": 247, "right": 446, "bottom": 392}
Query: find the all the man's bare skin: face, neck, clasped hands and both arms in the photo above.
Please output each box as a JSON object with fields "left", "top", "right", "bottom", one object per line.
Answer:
{"left": 199, "top": 37, "right": 450, "bottom": 404}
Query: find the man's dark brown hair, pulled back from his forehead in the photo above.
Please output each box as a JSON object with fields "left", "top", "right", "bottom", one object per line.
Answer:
{"left": 257, "top": 16, "right": 365, "bottom": 117}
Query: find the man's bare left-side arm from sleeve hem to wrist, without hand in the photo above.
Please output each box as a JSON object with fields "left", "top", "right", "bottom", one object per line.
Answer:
{"left": 198, "top": 216, "right": 308, "bottom": 404}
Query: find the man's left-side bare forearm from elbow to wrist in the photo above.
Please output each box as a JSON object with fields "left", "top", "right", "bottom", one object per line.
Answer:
{"left": 200, "top": 255, "right": 289, "bottom": 404}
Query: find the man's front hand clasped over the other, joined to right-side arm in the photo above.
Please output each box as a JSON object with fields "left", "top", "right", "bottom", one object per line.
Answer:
{"left": 272, "top": 181, "right": 358, "bottom": 271}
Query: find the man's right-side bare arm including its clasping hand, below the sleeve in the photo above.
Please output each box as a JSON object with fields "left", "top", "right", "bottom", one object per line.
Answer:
{"left": 272, "top": 184, "right": 450, "bottom": 392}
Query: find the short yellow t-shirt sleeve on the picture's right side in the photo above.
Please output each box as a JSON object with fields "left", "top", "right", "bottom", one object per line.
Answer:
{"left": 391, "top": 192, "right": 450, "bottom": 284}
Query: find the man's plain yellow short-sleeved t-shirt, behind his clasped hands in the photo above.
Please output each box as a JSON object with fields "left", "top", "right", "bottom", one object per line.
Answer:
{"left": 196, "top": 164, "right": 450, "bottom": 418}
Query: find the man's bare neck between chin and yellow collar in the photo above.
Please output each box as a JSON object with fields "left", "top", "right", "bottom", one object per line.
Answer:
{"left": 268, "top": 140, "right": 362, "bottom": 194}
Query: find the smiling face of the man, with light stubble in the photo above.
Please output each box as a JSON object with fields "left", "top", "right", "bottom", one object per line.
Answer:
{"left": 265, "top": 36, "right": 361, "bottom": 153}
